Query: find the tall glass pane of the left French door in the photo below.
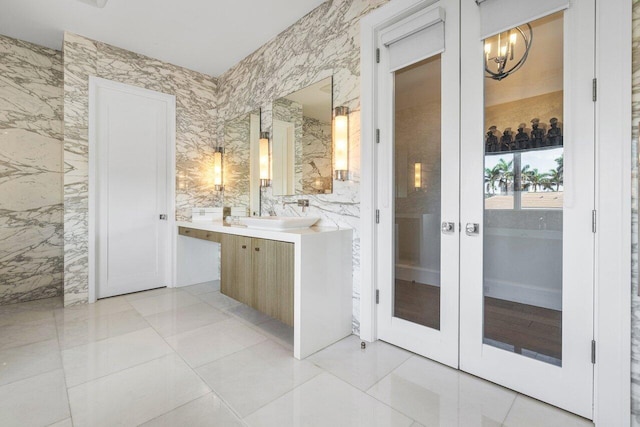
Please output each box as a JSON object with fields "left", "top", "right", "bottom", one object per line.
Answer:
{"left": 393, "top": 55, "right": 442, "bottom": 330}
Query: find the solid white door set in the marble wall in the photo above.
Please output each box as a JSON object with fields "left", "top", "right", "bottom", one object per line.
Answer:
{"left": 92, "top": 79, "right": 175, "bottom": 298}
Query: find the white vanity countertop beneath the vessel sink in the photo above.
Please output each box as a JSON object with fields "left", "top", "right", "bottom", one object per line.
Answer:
{"left": 176, "top": 220, "right": 350, "bottom": 243}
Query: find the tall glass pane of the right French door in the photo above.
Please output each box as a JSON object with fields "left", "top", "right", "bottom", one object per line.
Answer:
{"left": 483, "top": 12, "right": 564, "bottom": 366}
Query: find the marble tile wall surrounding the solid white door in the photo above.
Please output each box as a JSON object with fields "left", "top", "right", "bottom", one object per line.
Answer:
{"left": 63, "top": 33, "right": 221, "bottom": 305}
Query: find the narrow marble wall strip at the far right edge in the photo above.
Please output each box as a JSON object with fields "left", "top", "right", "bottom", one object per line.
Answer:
{"left": 631, "top": 0, "right": 640, "bottom": 426}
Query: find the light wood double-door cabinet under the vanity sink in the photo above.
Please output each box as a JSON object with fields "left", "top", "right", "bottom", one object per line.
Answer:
{"left": 220, "top": 234, "right": 294, "bottom": 326}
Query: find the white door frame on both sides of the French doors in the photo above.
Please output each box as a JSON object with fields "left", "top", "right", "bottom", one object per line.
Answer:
{"left": 360, "top": 0, "right": 632, "bottom": 425}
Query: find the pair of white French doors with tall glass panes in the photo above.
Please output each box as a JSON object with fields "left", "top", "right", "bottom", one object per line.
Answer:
{"left": 376, "top": 0, "right": 595, "bottom": 418}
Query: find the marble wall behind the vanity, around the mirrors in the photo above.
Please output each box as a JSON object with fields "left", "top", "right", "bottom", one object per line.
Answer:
{"left": 218, "top": 0, "right": 387, "bottom": 331}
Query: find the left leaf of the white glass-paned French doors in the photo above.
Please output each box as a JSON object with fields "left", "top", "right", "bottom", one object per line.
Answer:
{"left": 376, "top": 0, "right": 460, "bottom": 367}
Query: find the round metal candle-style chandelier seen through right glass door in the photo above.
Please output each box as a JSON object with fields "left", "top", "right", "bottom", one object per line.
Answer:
{"left": 484, "top": 24, "right": 533, "bottom": 80}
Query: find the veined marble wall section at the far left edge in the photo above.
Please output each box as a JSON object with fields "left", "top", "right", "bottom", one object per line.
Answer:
{"left": 0, "top": 36, "right": 63, "bottom": 305}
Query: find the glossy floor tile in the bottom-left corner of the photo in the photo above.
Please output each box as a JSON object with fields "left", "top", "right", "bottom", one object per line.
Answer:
{"left": 0, "top": 369, "right": 70, "bottom": 427}
